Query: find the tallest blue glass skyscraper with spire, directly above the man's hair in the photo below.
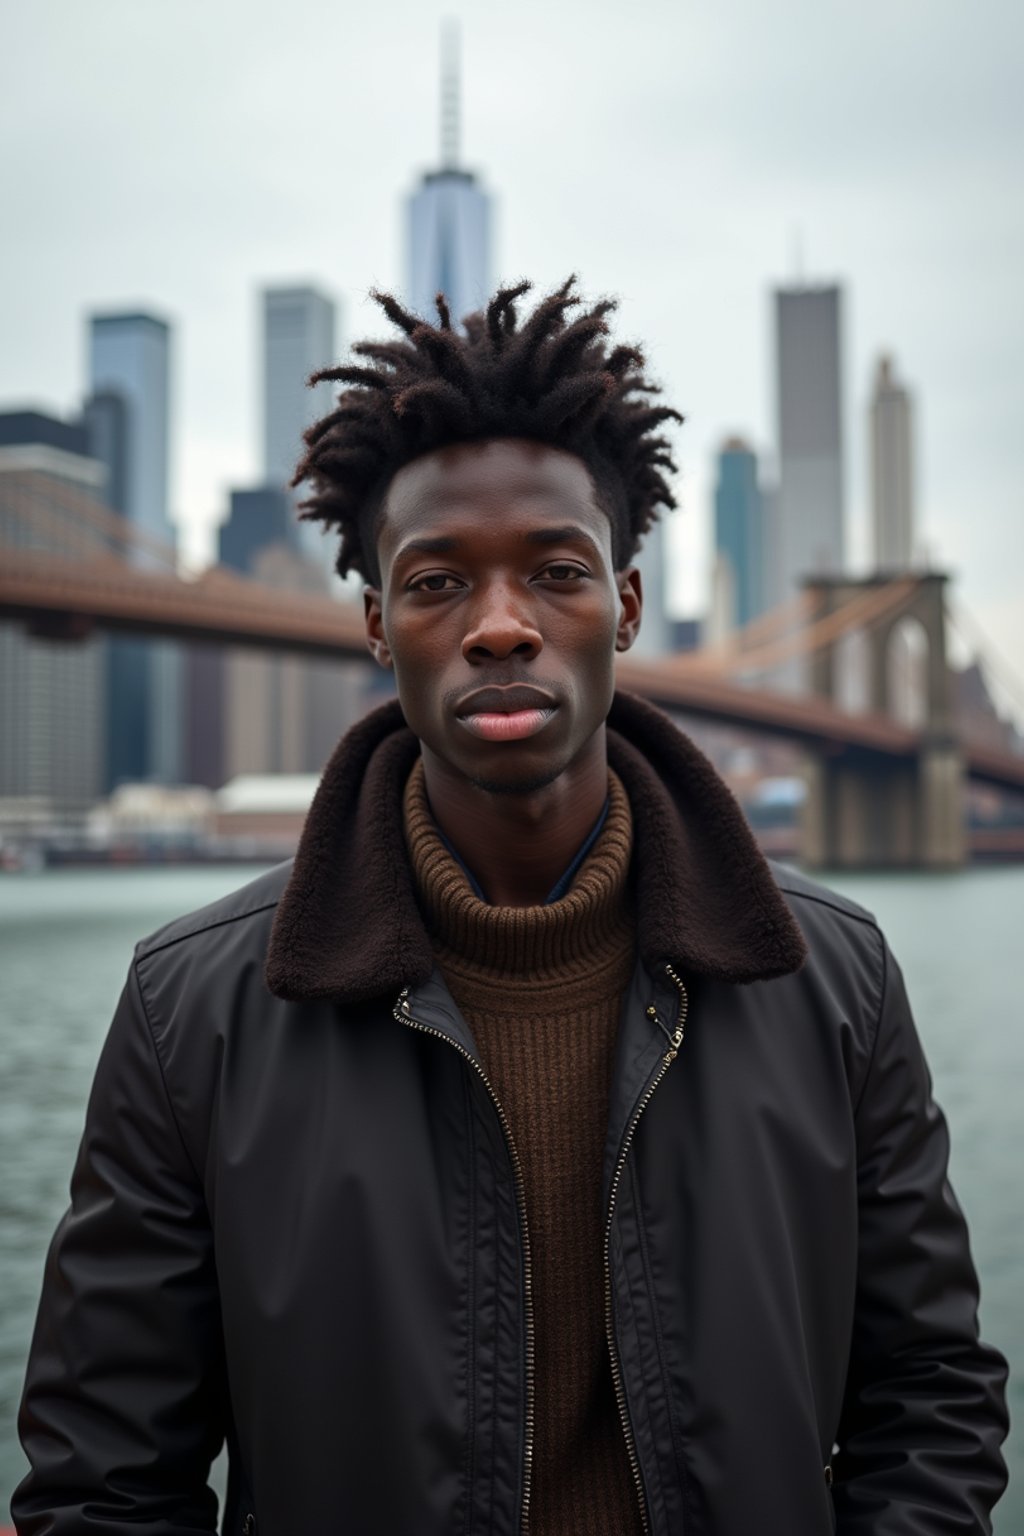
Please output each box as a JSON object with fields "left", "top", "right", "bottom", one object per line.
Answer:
{"left": 407, "top": 25, "right": 491, "bottom": 321}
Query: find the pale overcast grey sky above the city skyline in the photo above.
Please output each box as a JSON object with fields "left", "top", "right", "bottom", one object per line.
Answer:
{"left": 0, "top": 0, "right": 1024, "bottom": 713}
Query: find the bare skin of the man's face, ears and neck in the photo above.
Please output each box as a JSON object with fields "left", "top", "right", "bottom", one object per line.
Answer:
{"left": 365, "top": 438, "right": 642, "bottom": 906}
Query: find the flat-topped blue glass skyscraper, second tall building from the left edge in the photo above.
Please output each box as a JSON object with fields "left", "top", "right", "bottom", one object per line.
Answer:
{"left": 84, "top": 312, "right": 183, "bottom": 788}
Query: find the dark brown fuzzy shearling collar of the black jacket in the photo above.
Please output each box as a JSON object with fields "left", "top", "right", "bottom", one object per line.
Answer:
{"left": 266, "top": 693, "right": 806, "bottom": 1001}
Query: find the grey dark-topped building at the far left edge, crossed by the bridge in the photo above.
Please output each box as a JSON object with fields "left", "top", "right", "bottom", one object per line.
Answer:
{"left": 0, "top": 410, "right": 106, "bottom": 833}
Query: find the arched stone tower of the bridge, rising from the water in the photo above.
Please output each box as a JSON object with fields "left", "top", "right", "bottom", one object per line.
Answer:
{"left": 801, "top": 571, "right": 966, "bottom": 869}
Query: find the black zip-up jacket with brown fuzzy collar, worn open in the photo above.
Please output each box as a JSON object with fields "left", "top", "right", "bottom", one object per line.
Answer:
{"left": 12, "top": 694, "right": 1006, "bottom": 1536}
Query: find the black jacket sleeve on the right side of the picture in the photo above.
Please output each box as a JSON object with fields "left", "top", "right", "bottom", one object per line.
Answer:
{"left": 834, "top": 949, "right": 1007, "bottom": 1536}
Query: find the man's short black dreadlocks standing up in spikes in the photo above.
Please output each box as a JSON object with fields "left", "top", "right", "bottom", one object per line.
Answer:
{"left": 292, "top": 276, "right": 683, "bottom": 584}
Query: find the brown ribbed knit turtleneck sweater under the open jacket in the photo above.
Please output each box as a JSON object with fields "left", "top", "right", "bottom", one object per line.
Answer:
{"left": 404, "top": 760, "right": 640, "bottom": 1536}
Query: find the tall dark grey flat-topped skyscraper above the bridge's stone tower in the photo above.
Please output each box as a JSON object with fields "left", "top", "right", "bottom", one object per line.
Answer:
{"left": 772, "top": 286, "right": 844, "bottom": 601}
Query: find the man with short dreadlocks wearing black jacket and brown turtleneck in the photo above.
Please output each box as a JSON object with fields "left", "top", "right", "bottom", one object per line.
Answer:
{"left": 14, "top": 283, "right": 1006, "bottom": 1536}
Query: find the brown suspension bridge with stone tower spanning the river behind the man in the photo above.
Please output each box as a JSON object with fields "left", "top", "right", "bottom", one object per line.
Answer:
{"left": 0, "top": 473, "right": 1024, "bottom": 868}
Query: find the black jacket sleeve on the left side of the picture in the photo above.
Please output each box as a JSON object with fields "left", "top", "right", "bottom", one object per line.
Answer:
{"left": 11, "top": 968, "right": 224, "bottom": 1536}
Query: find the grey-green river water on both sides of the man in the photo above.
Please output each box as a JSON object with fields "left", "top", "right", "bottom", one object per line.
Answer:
{"left": 0, "top": 868, "right": 1024, "bottom": 1536}
